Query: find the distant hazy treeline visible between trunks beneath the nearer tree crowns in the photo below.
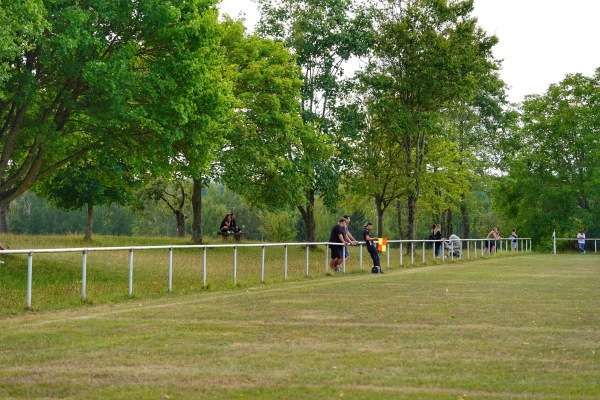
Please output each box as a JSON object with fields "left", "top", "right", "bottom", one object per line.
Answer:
{"left": 10, "top": 183, "right": 506, "bottom": 242}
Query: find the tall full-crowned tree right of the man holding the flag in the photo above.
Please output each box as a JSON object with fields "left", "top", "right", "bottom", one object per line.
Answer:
{"left": 359, "top": 0, "right": 498, "bottom": 239}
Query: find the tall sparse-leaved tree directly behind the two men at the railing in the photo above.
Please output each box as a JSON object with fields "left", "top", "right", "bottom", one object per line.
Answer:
{"left": 257, "top": 0, "right": 371, "bottom": 242}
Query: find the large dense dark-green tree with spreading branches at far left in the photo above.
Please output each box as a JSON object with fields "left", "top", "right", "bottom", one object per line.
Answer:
{"left": 0, "top": 0, "right": 222, "bottom": 231}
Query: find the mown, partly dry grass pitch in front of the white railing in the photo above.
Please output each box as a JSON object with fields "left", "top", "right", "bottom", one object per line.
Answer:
{"left": 0, "top": 254, "right": 600, "bottom": 399}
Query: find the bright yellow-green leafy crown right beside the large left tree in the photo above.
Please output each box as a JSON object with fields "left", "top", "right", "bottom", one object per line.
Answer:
{"left": 216, "top": 19, "right": 312, "bottom": 209}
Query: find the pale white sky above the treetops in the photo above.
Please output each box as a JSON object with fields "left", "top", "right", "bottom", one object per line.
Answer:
{"left": 220, "top": 0, "right": 600, "bottom": 102}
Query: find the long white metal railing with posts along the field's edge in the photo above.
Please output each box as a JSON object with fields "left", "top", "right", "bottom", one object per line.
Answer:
{"left": 0, "top": 238, "right": 532, "bottom": 308}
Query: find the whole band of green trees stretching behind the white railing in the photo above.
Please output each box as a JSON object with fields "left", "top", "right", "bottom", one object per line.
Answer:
{"left": 0, "top": 0, "right": 600, "bottom": 247}
